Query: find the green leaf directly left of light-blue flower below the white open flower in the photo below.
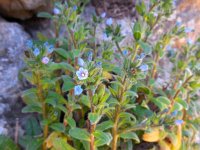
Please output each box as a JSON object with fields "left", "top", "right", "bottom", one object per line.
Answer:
{"left": 62, "top": 75, "right": 75, "bottom": 92}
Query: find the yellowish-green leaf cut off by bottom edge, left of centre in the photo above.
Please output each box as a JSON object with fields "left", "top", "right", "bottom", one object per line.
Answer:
{"left": 53, "top": 138, "right": 75, "bottom": 150}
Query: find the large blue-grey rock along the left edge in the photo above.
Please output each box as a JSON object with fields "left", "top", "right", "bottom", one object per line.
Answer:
{"left": 0, "top": 19, "right": 30, "bottom": 135}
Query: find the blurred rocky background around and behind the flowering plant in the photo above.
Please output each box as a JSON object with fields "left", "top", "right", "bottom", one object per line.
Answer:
{"left": 0, "top": 0, "right": 200, "bottom": 141}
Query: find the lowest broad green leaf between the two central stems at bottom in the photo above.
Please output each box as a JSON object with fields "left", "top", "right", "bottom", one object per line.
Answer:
{"left": 94, "top": 130, "right": 112, "bottom": 147}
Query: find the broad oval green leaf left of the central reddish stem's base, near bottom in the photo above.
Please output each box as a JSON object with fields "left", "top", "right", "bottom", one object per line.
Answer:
{"left": 69, "top": 128, "right": 90, "bottom": 141}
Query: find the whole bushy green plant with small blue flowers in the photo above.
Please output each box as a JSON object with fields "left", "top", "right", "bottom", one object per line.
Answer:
{"left": 21, "top": 0, "right": 200, "bottom": 150}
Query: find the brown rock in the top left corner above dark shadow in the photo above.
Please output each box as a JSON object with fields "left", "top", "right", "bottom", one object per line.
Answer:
{"left": 0, "top": 0, "right": 49, "bottom": 20}
